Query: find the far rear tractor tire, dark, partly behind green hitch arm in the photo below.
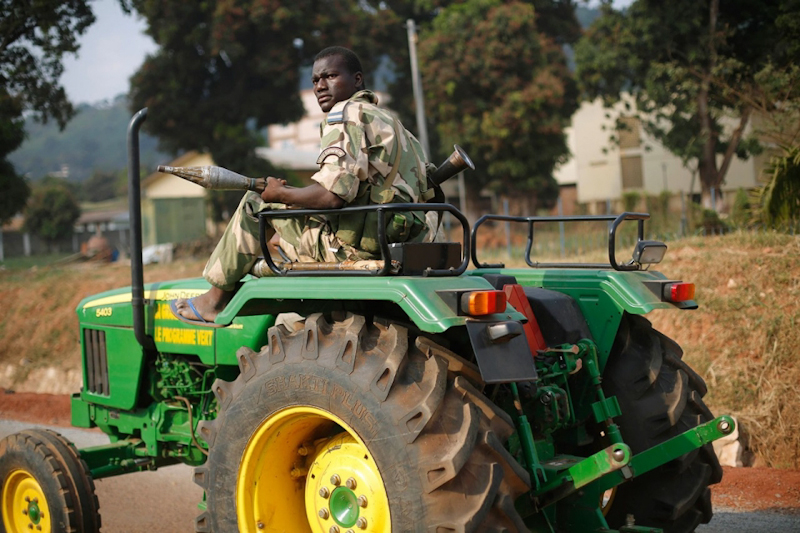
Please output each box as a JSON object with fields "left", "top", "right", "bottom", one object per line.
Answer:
{"left": 603, "top": 314, "right": 722, "bottom": 533}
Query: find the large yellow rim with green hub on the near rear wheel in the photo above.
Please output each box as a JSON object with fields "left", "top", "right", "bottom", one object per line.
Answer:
{"left": 236, "top": 407, "right": 392, "bottom": 533}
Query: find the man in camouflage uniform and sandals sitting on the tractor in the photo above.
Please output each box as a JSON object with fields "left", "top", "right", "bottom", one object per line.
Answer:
{"left": 173, "top": 47, "right": 434, "bottom": 326}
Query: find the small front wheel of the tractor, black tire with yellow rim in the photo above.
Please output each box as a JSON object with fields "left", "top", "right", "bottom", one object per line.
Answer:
{"left": 0, "top": 429, "right": 100, "bottom": 533}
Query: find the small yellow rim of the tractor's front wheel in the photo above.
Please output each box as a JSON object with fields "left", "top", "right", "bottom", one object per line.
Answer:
{"left": 0, "top": 470, "right": 51, "bottom": 533}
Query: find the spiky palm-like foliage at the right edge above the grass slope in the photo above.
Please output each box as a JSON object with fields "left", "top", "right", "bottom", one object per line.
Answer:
{"left": 756, "top": 146, "right": 800, "bottom": 227}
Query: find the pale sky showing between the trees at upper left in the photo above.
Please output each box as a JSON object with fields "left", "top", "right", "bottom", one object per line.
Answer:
{"left": 61, "top": 0, "right": 633, "bottom": 104}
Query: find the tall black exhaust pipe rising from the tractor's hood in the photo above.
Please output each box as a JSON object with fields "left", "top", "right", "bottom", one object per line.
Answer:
{"left": 128, "top": 107, "right": 156, "bottom": 352}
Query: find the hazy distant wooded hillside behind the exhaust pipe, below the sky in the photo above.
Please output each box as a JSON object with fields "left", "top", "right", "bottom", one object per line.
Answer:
{"left": 9, "top": 95, "right": 172, "bottom": 181}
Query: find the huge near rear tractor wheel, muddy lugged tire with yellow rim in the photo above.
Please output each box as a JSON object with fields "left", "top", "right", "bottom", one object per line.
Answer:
{"left": 195, "top": 314, "right": 530, "bottom": 533}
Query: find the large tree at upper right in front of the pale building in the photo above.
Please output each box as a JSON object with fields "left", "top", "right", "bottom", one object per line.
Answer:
{"left": 575, "top": 0, "right": 797, "bottom": 207}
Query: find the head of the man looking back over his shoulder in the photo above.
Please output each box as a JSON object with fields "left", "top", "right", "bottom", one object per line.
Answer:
{"left": 311, "top": 46, "right": 366, "bottom": 113}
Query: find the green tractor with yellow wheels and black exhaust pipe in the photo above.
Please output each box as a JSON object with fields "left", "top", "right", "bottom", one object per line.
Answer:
{"left": 0, "top": 110, "right": 734, "bottom": 533}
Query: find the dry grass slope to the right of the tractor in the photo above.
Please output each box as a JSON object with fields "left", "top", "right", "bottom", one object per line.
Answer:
{"left": 650, "top": 233, "right": 800, "bottom": 468}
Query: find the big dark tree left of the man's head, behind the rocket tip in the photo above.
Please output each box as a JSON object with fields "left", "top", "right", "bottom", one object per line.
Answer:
{"left": 124, "top": 0, "right": 394, "bottom": 179}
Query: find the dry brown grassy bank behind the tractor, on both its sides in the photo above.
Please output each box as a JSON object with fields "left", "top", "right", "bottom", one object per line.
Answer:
{"left": 0, "top": 233, "right": 800, "bottom": 468}
